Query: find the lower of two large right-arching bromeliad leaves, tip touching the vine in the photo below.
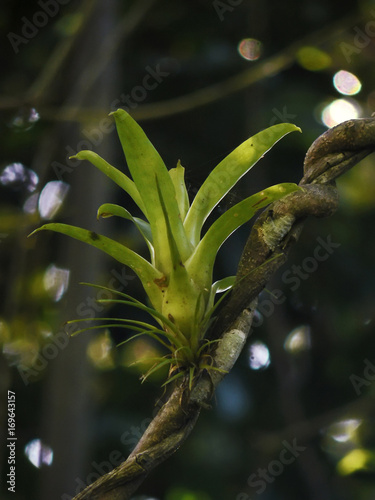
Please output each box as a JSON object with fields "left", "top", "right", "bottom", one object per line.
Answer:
{"left": 186, "top": 183, "right": 301, "bottom": 286}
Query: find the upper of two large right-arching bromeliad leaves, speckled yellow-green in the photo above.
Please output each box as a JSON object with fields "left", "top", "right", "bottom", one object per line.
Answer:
{"left": 184, "top": 123, "right": 300, "bottom": 247}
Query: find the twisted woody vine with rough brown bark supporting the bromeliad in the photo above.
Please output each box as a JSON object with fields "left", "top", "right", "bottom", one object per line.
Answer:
{"left": 75, "top": 118, "right": 375, "bottom": 500}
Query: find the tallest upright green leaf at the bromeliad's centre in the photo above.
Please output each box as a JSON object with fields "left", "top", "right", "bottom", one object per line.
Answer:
{"left": 111, "top": 109, "right": 192, "bottom": 274}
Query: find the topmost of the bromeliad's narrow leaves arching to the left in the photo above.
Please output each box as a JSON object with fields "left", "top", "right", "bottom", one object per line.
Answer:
{"left": 71, "top": 150, "right": 147, "bottom": 217}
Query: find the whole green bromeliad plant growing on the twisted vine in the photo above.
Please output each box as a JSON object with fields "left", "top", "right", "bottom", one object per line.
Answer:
{"left": 29, "top": 109, "right": 299, "bottom": 386}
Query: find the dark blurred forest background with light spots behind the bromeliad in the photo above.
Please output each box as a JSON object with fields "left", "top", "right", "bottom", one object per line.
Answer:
{"left": 0, "top": 0, "right": 375, "bottom": 500}
